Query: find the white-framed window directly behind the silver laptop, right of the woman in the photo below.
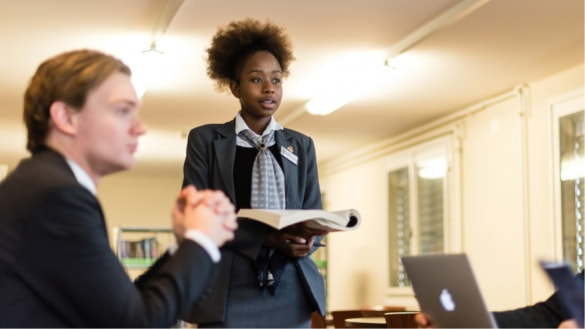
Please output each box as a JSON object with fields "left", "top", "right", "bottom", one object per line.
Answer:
{"left": 387, "top": 138, "right": 450, "bottom": 287}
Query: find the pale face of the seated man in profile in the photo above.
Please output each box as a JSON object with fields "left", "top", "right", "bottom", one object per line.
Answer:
{"left": 74, "top": 73, "right": 146, "bottom": 177}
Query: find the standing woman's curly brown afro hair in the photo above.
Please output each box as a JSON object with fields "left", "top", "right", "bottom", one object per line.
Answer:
{"left": 207, "top": 18, "right": 295, "bottom": 91}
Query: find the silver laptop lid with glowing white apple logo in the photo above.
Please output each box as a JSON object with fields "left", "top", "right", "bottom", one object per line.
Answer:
{"left": 401, "top": 254, "right": 496, "bottom": 328}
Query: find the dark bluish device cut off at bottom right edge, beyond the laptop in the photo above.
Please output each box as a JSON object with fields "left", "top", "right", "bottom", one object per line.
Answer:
{"left": 540, "top": 261, "right": 585, "bottom": 328}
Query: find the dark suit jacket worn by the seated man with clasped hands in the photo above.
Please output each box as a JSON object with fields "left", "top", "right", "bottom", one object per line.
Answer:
{"left": 0, "top": 149, "right": 215, "bottom": 328}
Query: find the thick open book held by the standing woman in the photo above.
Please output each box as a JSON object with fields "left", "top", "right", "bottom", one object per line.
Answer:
{"left": 238, "top": 209, "right": 361, "bottom": 232}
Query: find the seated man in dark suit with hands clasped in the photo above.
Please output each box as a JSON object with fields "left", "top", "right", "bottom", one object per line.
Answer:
{"left": 0, "top": 50, "right": 237, "bottom": 328}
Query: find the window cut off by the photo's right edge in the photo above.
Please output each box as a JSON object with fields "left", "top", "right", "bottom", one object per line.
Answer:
{"left": 553, "top": 91, "right": 585, "bottom": 272}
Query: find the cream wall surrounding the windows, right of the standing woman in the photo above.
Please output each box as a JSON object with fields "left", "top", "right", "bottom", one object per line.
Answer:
{"left": 320, "top": 65, "right": 584, "bottom": 310}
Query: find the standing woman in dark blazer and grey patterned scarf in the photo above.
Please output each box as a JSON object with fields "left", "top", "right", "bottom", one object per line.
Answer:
{"left": 183, "top": 19, "right": 326, "bottom": 328}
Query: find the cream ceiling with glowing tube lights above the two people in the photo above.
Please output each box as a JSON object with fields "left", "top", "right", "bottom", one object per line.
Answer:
{"left": 0, "top": 0, "right": 584, "bottom": 174}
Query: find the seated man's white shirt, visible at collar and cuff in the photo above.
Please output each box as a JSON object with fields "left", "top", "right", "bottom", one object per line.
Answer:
{"left": 65, "top": 158, "right": 221, "bottom": 263}
